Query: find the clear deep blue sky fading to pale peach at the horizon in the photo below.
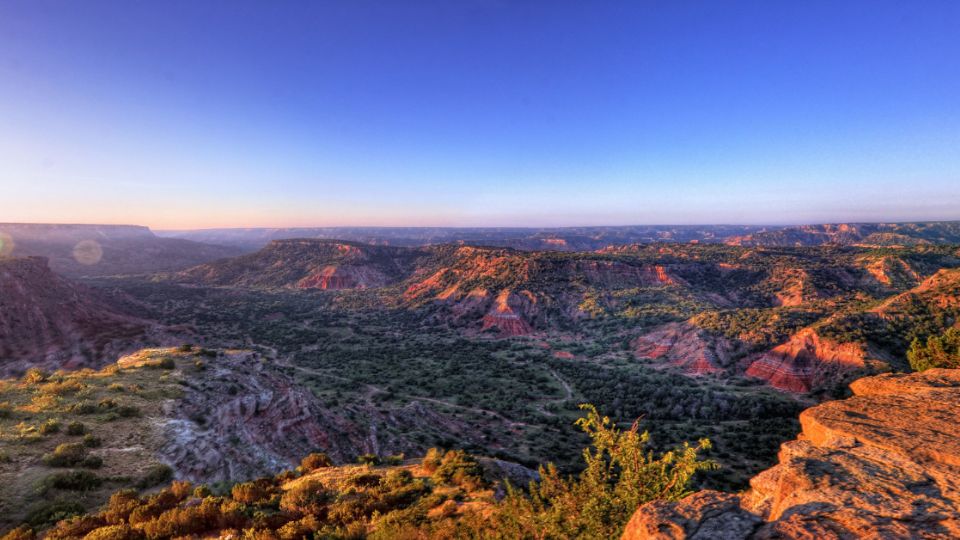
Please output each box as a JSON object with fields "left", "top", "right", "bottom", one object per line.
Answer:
{"left": 0, "top": 0, "right": 960, "bottom": 229}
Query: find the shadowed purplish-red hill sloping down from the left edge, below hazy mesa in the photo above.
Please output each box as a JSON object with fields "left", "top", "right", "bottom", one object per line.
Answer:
{"left": 0, "top": 257, "right": 157, "bottom": 374}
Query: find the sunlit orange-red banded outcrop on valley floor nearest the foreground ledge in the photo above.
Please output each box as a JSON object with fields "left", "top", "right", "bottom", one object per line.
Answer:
{"left": 746, "top": 328, "right": 868, "bottom": 392}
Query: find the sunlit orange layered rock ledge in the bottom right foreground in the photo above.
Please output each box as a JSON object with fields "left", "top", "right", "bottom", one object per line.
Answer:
{"left": 623, "top": 369, "right": 960, "bottom": 540}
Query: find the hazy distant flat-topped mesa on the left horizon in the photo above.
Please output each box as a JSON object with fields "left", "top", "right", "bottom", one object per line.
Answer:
{"left": 0, "top": 223, "right": 241, "bottom": 277}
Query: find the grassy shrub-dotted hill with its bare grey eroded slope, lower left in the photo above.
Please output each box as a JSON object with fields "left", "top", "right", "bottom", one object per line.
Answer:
{"left": 0, "top": 348, "right": 506, "bottom": 530}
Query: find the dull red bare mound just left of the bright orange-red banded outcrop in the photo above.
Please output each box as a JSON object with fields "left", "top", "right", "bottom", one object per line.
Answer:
{"left": 632, "top": 323, "right": 736, "bottom": 375}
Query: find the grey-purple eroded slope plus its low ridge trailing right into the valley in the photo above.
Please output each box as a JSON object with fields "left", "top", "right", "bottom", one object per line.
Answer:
{"left": 127, "top": 348, "right": 516, "bottom": 483}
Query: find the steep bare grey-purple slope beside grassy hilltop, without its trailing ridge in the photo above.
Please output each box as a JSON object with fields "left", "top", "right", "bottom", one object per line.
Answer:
{"left": 152, "top": 351, "right": 364, "bottom": 482}
